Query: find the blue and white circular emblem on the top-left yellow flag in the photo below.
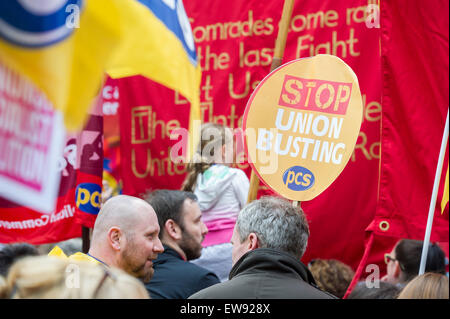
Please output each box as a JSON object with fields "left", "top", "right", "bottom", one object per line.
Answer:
{"left": 0, "top": 0, "right": 84, "bottom": 48}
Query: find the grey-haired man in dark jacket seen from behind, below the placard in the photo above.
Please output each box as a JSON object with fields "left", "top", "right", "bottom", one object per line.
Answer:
{"left": 189, "top": 197, "right": 335, "bottom": 299}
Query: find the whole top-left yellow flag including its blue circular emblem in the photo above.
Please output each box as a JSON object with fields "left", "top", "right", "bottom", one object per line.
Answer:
{"left": 0, "top": 0, "right": 120, "bottom": 130}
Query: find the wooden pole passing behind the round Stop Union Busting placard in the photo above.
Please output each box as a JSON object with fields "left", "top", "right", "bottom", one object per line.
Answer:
{"left": 247, "top": 0, "right": 294, "bottom": 203}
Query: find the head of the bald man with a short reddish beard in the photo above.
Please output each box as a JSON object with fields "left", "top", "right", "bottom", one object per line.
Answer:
{"left": 88, "top": 195, "right": 164, "bottom": 283}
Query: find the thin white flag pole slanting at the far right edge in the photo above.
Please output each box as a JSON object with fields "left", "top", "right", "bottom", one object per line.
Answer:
{"left": 419, "top": 110, "right": 448, "bottom": 275}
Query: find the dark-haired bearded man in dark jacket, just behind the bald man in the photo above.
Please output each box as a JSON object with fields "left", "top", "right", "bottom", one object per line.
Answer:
{"left": 145, "top": 190, "right": 220, "bottom": 299}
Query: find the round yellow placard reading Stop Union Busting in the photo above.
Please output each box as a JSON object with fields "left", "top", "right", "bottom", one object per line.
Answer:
{"left": 243, "top": 54, "right": 363, "bottom": 201}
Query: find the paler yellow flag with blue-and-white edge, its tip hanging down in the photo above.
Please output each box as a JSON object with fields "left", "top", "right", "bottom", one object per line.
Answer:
{"left": 106, "top": 0, "right": 201, "bottom": 158}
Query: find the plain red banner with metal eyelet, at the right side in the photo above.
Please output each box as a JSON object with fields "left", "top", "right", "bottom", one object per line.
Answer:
{"left": 347, "top": 0, "right": 449, "bottom": 295}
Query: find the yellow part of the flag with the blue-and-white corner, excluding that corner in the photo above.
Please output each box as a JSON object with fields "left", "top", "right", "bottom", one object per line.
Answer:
{"left": 106, "top": 0, "right": 201, "bottom": 158}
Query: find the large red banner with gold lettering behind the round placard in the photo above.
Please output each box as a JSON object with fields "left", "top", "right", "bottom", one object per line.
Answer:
{"left": 119, "top": 0, "right": 381, "bottom": 274}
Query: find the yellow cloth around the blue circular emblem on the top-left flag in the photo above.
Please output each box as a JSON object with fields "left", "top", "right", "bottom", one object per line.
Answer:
{"left": 0, "top": 0, "right": 121, "bottom": 130}
